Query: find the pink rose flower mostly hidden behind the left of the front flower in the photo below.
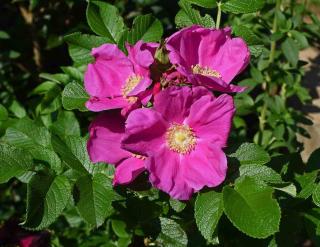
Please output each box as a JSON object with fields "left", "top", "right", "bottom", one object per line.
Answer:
{"left": 87, "top": 111, "right": 145, "bottom": 185}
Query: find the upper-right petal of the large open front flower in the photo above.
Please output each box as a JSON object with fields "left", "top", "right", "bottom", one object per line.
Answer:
{"left": 186, "top": 94, "right": 235, "bottom": 148}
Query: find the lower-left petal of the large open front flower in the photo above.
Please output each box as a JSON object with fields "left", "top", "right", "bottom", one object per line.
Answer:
{"left": 146, "top": 147, "right": 193, "bottom": 200}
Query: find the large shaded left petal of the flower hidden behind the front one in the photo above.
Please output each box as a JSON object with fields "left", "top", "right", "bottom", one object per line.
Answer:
{"left": 87, "top": 111, "right": 131, "bottom": 164}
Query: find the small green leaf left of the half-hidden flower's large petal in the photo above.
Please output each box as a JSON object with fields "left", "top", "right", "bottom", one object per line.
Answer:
{"left": 50, "top": 111, "right": 80, "bottom": 138}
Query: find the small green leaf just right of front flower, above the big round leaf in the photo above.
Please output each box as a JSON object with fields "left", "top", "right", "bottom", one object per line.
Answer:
{"left": 230, "top": 143, "right": 270, "bottom": 165}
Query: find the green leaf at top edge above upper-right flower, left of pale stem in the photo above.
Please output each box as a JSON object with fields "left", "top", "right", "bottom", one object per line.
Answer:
{"left": 175, "top": 0, "right": 215, "bottom": 28}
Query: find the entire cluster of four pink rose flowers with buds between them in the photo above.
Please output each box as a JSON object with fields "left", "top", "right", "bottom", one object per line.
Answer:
{"left": 85, "top": 26, "right": 250, "bottom": 200}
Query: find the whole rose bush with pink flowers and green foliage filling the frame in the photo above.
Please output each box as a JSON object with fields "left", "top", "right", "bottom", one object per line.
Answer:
{"left": 0, "top": 0, "right": 320, "bottom": 246}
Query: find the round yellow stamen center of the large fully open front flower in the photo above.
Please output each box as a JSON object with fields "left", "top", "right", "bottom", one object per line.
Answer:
{"left": 166, "top": 124, "right": 197, "bottom": 154}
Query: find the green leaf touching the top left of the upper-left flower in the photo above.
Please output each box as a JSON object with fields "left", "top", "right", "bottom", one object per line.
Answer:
{"left": 64, "top": 32, "right": 110, "bottom": 64}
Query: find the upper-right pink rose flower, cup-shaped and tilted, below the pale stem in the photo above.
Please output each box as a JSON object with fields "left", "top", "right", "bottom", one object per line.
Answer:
{"left": 166, "top": 26, "right": 250, "bottom": 92}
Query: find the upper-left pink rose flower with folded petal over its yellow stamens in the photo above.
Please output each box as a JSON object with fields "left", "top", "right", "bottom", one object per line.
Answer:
{"left": 84, "top": 41, "right": 158, "bottom": 114}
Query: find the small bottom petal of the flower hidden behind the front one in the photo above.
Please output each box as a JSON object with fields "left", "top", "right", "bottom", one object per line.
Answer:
{"left": 113, "top": 157, "right": 145, "bottom": 185}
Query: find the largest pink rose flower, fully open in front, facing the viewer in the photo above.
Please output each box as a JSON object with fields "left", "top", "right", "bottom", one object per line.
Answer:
{"left": 122, "top": 87, "right": 235, "bottom": 200}
